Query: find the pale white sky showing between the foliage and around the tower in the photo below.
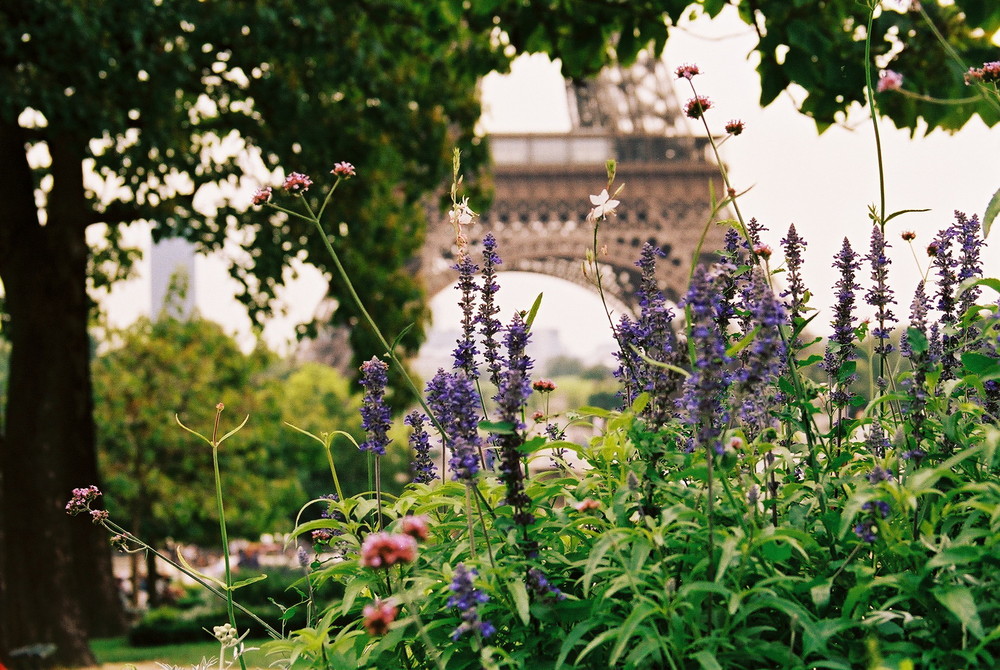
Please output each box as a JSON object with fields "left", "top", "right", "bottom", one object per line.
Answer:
{"left": 104, "top": 2, "right": 1000, "bottom": 359}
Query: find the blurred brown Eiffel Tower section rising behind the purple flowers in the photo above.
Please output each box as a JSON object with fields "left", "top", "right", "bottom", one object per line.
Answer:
{"left": 419, "top": 54, "right": 724, "bottom": 311}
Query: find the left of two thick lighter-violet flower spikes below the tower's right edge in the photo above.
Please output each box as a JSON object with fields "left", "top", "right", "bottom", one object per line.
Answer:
{"left": 681, "top": 265, "right": 730, "bottom": 455}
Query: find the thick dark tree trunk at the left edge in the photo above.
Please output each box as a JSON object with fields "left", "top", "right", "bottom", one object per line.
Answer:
{"left": 0, "top": 121, "right": 124, "bottom": 665}
